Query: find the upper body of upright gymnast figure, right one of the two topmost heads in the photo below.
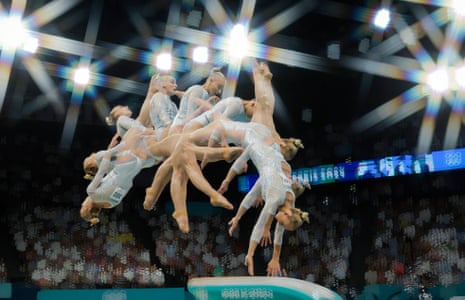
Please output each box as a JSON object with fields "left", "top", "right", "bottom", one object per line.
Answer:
{"left": 168, "top": 68, "right": 226, "bottom": 134}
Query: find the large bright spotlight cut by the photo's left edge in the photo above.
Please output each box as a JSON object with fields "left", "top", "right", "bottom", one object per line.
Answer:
{"left": 0, "top": 17, "right": 27, "bottom": 49}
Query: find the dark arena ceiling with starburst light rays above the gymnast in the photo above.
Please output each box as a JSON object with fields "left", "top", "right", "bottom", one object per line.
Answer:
{"left": 0, "top": 0, "right": 464, "bottom": 163}
